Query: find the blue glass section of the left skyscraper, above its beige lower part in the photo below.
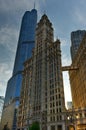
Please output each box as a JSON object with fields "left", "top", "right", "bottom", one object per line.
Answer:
{"left": 5, "top": 9, "right": 37, "bottom": 104}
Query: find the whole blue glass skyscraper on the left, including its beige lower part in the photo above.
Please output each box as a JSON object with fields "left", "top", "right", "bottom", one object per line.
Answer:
{"left": 2, "top": 9, "right": 37, "bottom": 130}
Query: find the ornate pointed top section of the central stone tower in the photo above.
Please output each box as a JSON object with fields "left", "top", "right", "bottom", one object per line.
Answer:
{"left": 36, "top": 14, "right": 53, "bottom": 44}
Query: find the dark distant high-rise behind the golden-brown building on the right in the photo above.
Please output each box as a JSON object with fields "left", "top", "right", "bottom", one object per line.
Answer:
{"left": 71, "top": 30, "right": 86, "bottom": 60}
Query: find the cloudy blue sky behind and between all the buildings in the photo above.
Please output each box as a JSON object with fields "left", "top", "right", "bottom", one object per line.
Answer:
{"left": 0, "top": 0, "right": 86, "bottom": 101}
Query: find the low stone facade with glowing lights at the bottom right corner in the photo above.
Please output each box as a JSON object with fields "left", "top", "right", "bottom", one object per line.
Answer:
{"left": 65, "top": 108, "right": 86, "bottom": 130}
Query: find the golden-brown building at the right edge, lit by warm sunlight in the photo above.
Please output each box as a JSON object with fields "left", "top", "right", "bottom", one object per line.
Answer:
{"left": 69, "top": 34, "right": 86, "bottom": 130}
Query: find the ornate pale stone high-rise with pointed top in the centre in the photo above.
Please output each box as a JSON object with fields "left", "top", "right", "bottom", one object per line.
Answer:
{"left": 17, "top": 14, "right": 65, "bottom": 130}
